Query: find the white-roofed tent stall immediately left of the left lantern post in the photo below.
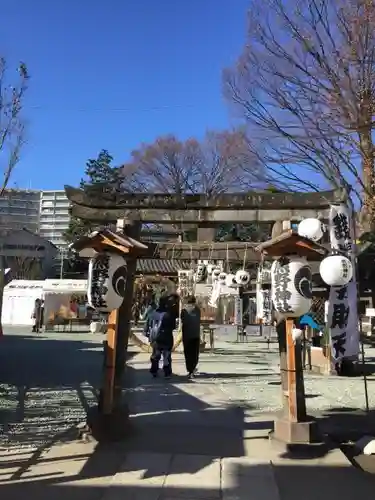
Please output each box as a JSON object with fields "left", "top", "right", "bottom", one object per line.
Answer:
{"left": 43, "top": 279, "right": 87, "bottom": 327}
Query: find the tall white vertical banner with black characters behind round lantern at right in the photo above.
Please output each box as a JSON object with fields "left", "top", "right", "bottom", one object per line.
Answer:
{"left": 327, "top": 204, "right": 359, "bottom": 360}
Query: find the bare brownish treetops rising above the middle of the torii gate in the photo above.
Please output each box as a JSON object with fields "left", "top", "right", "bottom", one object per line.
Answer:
{"left": 124, "top": 129, "right": 260, "bottom": 196}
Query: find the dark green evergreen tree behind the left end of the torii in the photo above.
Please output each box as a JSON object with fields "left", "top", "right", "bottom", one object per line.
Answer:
{"left": 64, "top": 149, "right": 124, "bottom": 243}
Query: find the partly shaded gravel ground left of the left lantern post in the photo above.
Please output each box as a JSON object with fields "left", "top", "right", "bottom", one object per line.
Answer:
{"left": 0, "top": 332, "right": 102, "bottom": 448}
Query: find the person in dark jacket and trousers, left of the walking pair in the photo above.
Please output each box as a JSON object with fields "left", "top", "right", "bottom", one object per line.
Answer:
{"left": 146, "top": 297, "right": 176, "bottom": 378}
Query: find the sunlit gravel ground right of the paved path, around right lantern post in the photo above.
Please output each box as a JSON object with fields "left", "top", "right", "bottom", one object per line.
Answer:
{"left": 207, "top": 342, "right": 375, "bottom": 413}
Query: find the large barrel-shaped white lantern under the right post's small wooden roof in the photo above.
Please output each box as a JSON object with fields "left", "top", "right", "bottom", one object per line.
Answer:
{"left": 271, "top": 256, "right": 312, "bottom": 318}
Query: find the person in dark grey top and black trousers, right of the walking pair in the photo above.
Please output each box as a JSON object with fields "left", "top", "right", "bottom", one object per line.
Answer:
{"left": 181, "top": 295, "right": 201, "bottom": 378}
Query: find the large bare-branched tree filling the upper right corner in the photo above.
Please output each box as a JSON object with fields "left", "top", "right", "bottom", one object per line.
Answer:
{"left": 224, "top": 0, "right": 375, "bottom": 229}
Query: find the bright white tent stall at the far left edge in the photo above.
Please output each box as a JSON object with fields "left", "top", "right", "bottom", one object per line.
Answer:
{"left": 1, "top": 280, "right": 44, "bottom": 327}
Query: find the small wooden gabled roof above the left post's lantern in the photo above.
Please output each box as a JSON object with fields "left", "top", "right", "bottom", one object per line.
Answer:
{"left": 69, "top": 229, "right": 148, "bottom": 258}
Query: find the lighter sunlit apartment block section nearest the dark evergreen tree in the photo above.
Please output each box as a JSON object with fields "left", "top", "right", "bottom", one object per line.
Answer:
{"left": 39, "top": 190, "right": 70, "bottom": 249}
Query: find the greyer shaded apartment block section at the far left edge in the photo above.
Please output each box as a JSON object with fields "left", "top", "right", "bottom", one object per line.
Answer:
{"left": 0, "top": 189, "right": 40, "bottom": 233}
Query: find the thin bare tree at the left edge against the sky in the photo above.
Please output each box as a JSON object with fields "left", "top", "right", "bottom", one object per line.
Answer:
{"left": 0, "top": 57, "right": 29, "bottom": 196}
